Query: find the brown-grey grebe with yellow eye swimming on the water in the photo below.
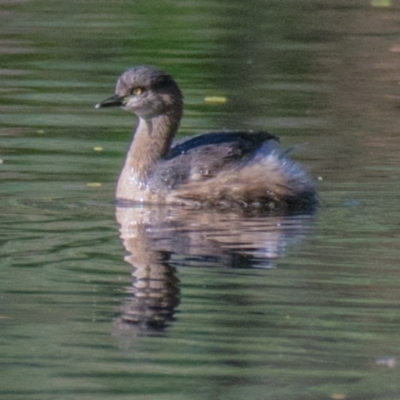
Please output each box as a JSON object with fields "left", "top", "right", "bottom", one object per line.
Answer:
{"left": 95, "top": 65, "right": 318, "bottom": 213}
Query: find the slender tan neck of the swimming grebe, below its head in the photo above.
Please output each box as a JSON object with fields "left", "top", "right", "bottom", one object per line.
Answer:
{"left": 122, "top": 115, "right": 180, "bottom": 185}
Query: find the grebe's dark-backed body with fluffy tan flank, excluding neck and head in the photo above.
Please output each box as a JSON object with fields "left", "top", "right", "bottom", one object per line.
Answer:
{"left": 149, "top": 131, "right": 315, "bottom": 210}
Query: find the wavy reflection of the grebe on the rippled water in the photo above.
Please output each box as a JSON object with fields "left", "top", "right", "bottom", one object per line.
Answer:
{"left": 114, "top": 204, "right": 313, "bottom": 338}
